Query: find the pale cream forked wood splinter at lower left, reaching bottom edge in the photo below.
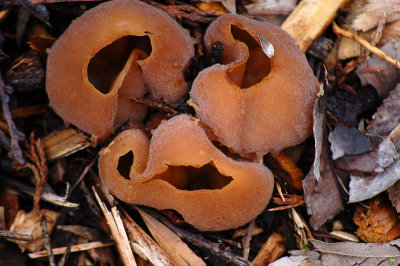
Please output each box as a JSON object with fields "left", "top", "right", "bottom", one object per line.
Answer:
{"left": 92, "top": 187, "right": 136, "bottom": 266}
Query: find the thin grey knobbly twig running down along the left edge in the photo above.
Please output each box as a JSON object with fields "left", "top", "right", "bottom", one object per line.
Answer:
{"left": 0, "top": 73, "right": 25, "bottom": 165}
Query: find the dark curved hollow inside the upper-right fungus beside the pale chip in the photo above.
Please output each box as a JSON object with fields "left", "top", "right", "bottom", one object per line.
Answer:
{"left": 231, "top": 25, "right": 271, "bottom": 89}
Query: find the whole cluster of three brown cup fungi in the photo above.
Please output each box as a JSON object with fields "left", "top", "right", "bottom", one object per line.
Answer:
{"left": 46, "top": 0, "right": 318, "bottom": 231}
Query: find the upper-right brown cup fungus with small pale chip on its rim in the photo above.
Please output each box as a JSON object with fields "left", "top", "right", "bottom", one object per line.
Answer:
{"left": 190, "top": 15, "right": 318, "bottom": 155}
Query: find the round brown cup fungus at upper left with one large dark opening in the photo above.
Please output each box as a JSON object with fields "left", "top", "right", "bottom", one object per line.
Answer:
{"left": 46, "top": 0, "right": 194, "bottom": 137}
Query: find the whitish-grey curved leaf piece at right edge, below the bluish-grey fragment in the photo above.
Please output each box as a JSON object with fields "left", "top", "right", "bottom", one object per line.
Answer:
{"left": 349, "top": 157, "right": 400, "bottom": 203}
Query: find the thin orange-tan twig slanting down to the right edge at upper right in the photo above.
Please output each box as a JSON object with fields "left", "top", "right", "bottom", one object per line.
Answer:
{"left": 332, "top": 22, "right": 400, "bottom": 69}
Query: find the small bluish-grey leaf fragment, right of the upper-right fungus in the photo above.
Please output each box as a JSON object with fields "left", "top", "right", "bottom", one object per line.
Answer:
{"left": 329, "top": 123, "right": 371, "bottom": 160}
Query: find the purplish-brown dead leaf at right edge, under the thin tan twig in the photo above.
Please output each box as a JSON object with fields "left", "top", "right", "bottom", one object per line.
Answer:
{"left": 356, "top": 40, "right": 400, "bottom": 98}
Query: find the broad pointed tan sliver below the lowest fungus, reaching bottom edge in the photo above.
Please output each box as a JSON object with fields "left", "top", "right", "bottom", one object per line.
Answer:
{"left": 137, "top": 209, "right": 206, "bottom": 265}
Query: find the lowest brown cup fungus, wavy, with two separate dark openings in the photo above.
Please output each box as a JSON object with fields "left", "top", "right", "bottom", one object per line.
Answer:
{"left": 99, "top": 115, "right": 273, "bottom": 231}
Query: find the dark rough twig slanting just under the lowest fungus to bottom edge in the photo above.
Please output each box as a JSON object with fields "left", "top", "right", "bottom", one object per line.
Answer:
{"left": 140, "top": 208, "right": 252, "bottom": 266}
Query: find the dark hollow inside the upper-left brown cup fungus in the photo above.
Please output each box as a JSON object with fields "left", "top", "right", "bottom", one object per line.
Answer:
{"left": 87, "top": 35, "right": 152, "bottom": 94}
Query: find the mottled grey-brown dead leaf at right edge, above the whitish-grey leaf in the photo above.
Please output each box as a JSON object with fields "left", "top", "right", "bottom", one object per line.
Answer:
{"left": 367, "top": 83, "right": 400, "bottom": 149}
